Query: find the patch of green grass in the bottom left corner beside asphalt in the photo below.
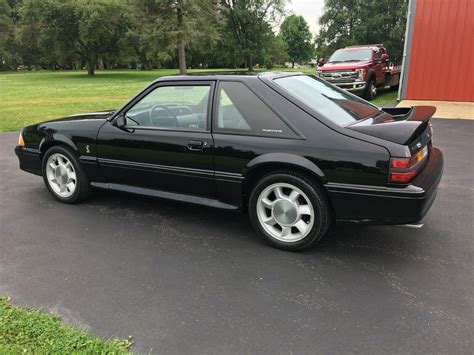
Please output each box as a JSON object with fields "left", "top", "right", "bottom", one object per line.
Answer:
{"left": 0, "top": 298, "right": 131, "bottom": 354}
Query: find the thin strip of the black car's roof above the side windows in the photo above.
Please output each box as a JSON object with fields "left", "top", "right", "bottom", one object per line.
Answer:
{"left": 154, "top": 71, "right": 306, "bottom": 83}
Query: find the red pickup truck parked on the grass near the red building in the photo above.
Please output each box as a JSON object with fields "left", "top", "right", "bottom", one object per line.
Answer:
{"left": 316, "top": 44, "right": 400, "bottom": 100}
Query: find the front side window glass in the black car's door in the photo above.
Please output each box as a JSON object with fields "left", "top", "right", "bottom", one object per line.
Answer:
{"left": 125, "top": 85, "right": 211, "bottom": 130}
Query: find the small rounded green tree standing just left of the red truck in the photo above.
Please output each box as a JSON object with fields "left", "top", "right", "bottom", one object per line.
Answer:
{"left": 280, "top": 15, "right": 313, "bottom": 68}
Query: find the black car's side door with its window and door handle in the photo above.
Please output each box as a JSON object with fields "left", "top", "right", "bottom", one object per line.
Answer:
{"left": 97, "top": 80, "right": 215, "bottom": 198}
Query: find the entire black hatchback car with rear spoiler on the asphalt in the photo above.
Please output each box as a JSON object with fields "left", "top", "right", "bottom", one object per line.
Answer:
{"left": 15, "top": 73, "right": 443, "bottom": 250}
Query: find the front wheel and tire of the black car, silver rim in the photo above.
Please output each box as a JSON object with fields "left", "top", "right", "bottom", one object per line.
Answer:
{"left": 42, "top": 145, "right": 91, "bottom": 204}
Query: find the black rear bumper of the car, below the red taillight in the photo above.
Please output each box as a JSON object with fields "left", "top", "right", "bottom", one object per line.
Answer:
{"left": 326, "top": 148, "right": 444, "bottom": 224}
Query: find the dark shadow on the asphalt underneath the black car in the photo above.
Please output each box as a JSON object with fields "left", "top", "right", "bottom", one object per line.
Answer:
{"left": 86, "top": 186, "right": 422, "bottom": 261}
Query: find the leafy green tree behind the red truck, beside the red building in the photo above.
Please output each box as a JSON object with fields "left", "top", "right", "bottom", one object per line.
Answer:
{"left": 316, "top": 0, "right": 408, "bottom": 58}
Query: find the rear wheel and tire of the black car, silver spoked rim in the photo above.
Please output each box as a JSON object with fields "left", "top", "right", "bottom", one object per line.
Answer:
{"left": 249, "top": 171, "right": 331, "bottom": 251}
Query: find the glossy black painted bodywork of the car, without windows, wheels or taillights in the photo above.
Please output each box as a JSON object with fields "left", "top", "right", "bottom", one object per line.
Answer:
{"left": 16, "top": 74, "right": 443, "bottom": 223}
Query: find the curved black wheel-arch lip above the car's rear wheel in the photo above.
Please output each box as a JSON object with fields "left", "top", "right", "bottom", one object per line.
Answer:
{"left": 243, "top": 153, "right": 327, "bottom": 184}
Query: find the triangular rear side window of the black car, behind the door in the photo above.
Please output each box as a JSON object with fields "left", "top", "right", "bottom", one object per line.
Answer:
{"left": 214, "top": 81, "right": 296, "bottom": 138}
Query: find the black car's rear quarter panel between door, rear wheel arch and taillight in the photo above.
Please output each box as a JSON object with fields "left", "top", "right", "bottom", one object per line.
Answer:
{"left": 213, "top": 78, "right": 390, "bottom": 206}
